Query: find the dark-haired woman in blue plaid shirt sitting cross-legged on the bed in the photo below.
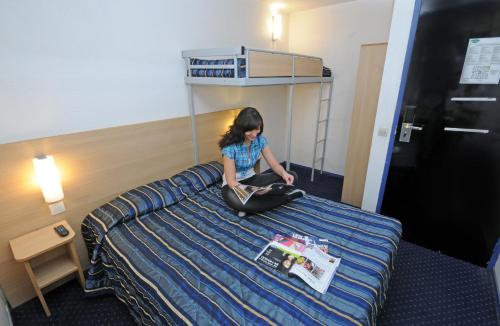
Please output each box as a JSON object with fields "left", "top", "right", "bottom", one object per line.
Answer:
{"left": 219, "top": 107, "right": 304, "bottom": 217}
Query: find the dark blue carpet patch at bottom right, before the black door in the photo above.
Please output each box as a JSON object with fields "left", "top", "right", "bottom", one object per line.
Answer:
{"left": 378, "top": 240, "right": 500, "bottom": 326}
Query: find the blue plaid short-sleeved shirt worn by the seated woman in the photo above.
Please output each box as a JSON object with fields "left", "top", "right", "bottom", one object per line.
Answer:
{"left": 221, "top": 134, "right": 267, "bottom": 184}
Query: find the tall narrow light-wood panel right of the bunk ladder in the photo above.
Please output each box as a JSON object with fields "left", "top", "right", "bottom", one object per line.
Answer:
{"left": 341, "top": 43, "right": 387, "bottom": 207}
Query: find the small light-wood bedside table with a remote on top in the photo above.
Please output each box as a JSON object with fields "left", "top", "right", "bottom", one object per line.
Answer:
{"left": 9, "top": 220, "right": 85, "bottom": 317}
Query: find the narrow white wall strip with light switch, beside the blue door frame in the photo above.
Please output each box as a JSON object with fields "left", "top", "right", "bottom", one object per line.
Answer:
{"left": 361, "top": 0, "right": 415, "bottom": 212}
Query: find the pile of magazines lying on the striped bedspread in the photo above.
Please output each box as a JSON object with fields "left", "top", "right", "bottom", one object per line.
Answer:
{"left": 255, "top": 234, "right": 340, "bottom": 294}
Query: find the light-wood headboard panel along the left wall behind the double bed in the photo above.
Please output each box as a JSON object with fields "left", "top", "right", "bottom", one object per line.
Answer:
{"left": 0, "top": 110, "right": 237, "bottom": 307}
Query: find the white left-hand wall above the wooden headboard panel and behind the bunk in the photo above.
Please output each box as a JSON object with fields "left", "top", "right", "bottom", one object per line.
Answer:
{"left": 0, "top": 0, "right": 288, "bottom": 159}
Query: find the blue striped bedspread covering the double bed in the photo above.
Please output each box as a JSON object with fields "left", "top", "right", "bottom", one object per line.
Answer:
{"left": 82, "top": 162, "right": 401, "bottom": 325}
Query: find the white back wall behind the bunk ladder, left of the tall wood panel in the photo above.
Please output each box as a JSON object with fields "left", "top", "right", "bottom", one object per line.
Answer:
{"left": 289, "top": 0, "right": 393, "bottom": 175}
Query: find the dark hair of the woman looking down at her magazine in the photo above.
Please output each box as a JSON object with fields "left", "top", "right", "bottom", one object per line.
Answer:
{"left": 219, "top": 107, "right": 264, "bottom": 149}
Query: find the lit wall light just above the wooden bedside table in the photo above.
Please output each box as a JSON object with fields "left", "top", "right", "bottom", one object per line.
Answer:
{"left": 33, "top": 155, "right": 66, "bottom": 215}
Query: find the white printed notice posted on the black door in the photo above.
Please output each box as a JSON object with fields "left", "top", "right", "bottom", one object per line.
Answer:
{"left": 460, "top": 37, "right": 500, "bottom": 84}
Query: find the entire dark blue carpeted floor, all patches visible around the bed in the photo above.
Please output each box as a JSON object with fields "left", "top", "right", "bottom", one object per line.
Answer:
{"left": 12, "top": 165, "right": 500, "bottom": 326}
